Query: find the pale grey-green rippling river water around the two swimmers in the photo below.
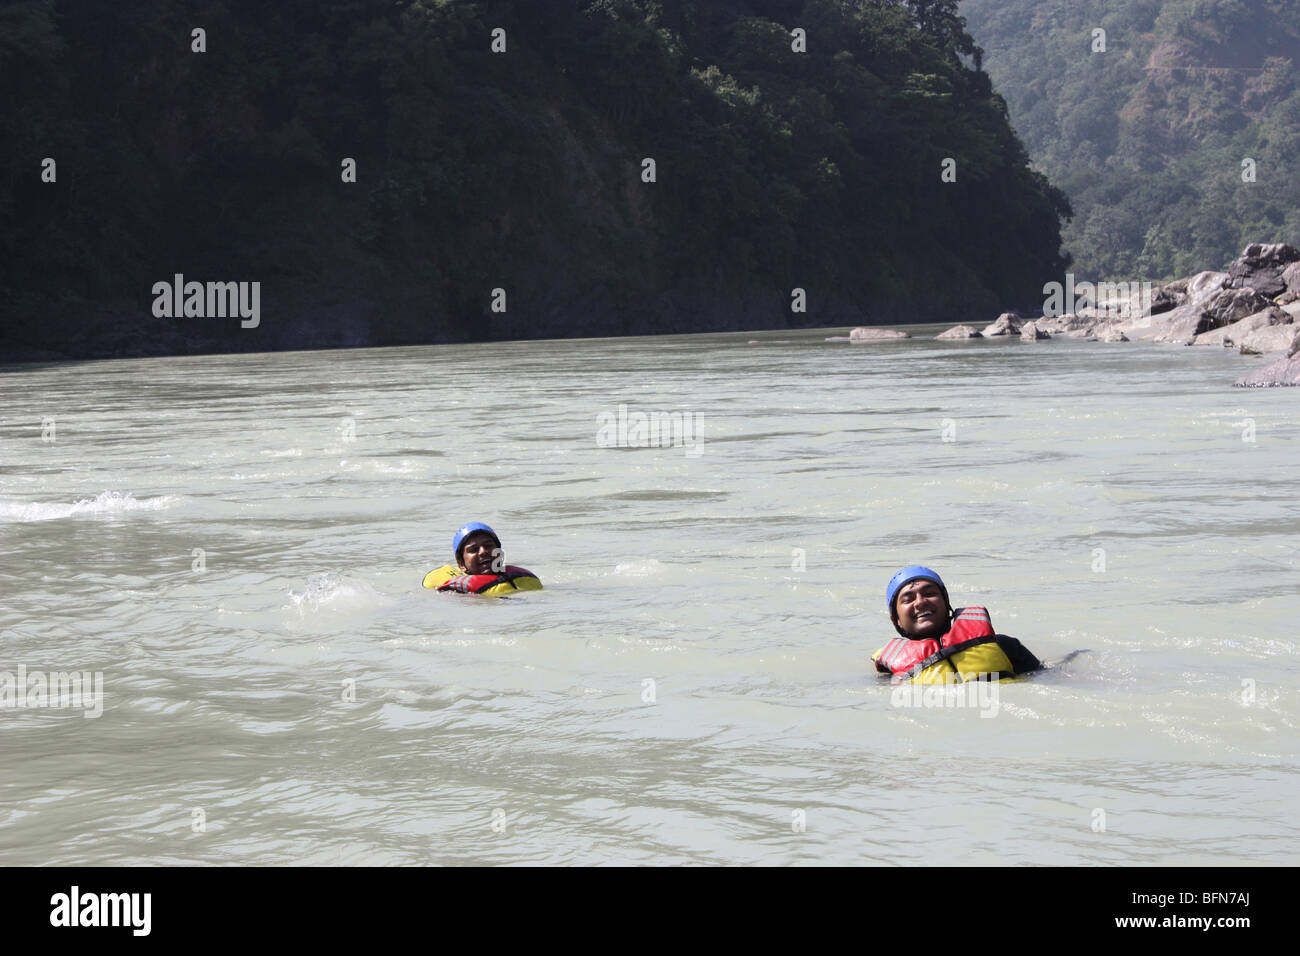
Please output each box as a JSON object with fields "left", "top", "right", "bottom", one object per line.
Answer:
{"left": 0, "top": 326, "right": 1300, "bottom": 865}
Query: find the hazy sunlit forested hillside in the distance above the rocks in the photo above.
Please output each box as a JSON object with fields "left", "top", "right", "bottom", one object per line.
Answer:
{"left": 961, "top": 0, "right": 1300, "bottom": 280}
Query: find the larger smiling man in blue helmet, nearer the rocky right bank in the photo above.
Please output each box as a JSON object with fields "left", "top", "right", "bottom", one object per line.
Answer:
{"left": 871, "top": 564, "right": 1043, "bottom": 684}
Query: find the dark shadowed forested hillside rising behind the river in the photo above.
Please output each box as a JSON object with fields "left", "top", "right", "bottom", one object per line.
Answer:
{"left": 0, "top": 0, "right": 1067, "bottom": 358}
